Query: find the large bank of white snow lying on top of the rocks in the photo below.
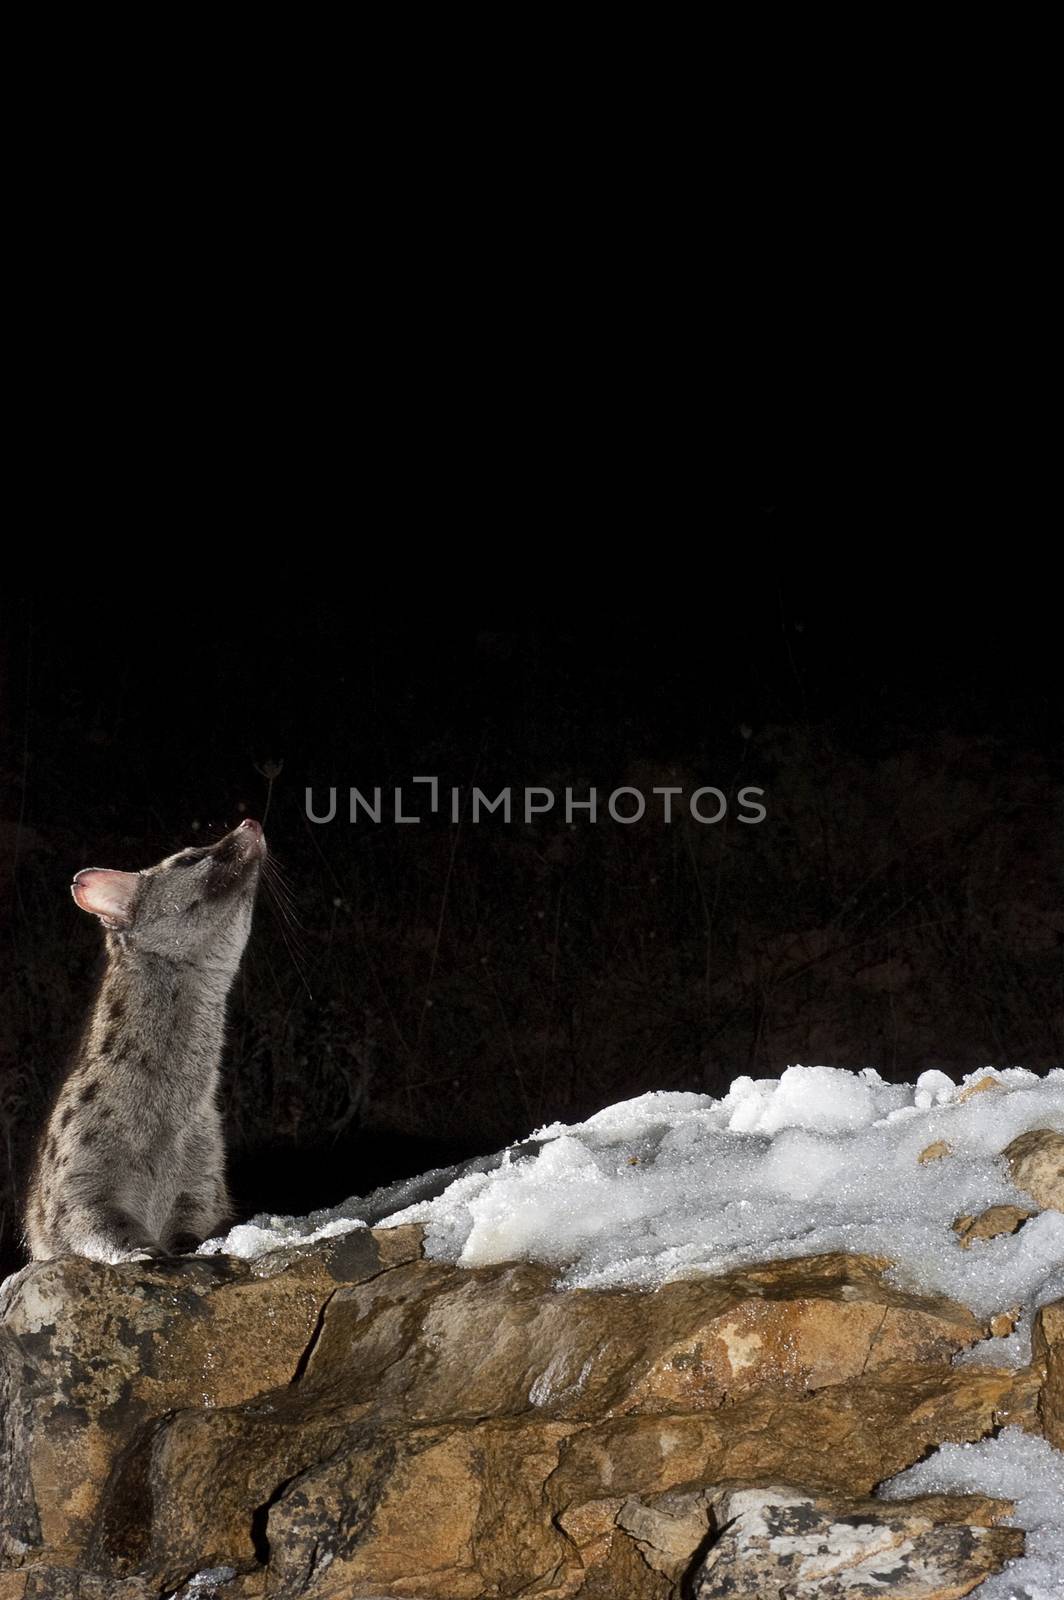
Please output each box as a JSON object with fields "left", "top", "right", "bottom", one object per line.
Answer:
{"left": 203, "top": 1066, "right": 1064, "bottom": 1324}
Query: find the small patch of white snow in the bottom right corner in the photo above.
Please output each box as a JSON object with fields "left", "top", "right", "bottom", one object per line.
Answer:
{"left": 878, "top": 1427, "right": 1064, "bottom": 1600}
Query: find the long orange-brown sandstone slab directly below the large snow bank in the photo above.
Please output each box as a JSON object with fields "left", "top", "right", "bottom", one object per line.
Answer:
{"left": 284, "top": 1256, "right": 984, "bottom": 1421}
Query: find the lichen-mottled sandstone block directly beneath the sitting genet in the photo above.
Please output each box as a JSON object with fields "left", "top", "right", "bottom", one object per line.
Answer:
{"left": 0, "top": 1229, "right": 416, "bottom": 1566}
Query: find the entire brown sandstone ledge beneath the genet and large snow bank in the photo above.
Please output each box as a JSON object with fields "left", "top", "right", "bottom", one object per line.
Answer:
{"left": 0, "top": 1203, "right": 1064, "bottom": 1600}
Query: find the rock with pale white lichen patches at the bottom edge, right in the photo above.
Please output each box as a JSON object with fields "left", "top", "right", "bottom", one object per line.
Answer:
{"left": 691, "top": 1486, "right": 1024, "bottom": 1600}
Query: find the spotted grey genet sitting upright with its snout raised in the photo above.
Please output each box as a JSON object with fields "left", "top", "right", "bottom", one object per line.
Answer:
{"left": 24, "top": 822, "right": 266, "bottom": 1262}
